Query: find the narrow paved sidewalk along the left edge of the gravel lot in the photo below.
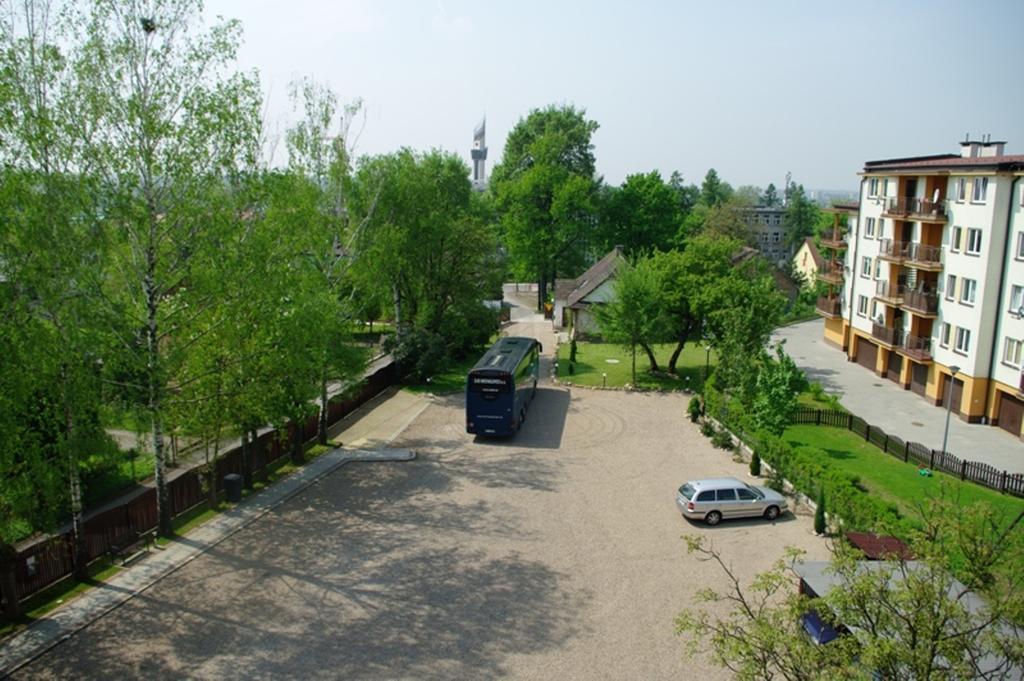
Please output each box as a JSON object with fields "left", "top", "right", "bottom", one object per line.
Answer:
{"left": 0, "top": 390, "right": 430, "bottom": 678}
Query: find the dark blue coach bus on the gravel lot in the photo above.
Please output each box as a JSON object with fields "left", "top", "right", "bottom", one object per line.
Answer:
{"left": 466, "top": 336, "right": 543, "bottom": 435}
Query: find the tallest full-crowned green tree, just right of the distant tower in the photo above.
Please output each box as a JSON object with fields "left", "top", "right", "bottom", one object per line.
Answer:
{"left": 490, "top": 105, "right": 598, "bottom": 308}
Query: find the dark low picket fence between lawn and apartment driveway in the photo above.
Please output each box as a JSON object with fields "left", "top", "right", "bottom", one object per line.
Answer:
{"left": 793, "top": 408, "right": 1024, "bottom": 497}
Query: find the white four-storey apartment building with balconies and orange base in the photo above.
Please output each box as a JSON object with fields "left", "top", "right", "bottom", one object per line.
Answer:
{"left": 818, "top": 140, "right": 1024, "bottom": 436}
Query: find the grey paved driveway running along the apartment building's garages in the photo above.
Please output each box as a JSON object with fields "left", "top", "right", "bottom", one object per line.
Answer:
{"left": 775, "top": 320, "right": 1024, "bottom": 473}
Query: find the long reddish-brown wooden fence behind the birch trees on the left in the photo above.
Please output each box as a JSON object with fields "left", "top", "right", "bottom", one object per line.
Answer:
{"left": 0, "top": 365, "right": 396, "bottom": 602}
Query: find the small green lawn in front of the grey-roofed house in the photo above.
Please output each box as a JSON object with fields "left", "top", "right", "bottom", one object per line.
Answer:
{"left": 558, "top": 342, "right": 715, "bottom": 390}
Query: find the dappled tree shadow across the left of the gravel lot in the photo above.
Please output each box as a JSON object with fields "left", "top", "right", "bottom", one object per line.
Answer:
{"left": 26, "top": 442, "right": 593, "bottom": 678}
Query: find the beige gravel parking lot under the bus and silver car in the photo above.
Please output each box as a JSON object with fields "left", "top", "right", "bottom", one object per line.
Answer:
{"left": 19, "top": 317, "right": 827, "bottom": 679}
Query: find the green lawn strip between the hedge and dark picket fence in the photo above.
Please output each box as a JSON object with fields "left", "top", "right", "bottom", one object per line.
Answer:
{"left": 782, "top": 425, "right": 1024, "bottom": 517}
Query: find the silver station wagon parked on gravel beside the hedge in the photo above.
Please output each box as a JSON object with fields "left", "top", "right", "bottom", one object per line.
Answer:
{"left": 676, "top": 477, "right": 786, "bottom": 525}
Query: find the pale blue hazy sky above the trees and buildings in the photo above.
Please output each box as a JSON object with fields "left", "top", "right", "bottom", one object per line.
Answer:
{"left": 205, "top": 0, "right": 1024, "bottom": 190}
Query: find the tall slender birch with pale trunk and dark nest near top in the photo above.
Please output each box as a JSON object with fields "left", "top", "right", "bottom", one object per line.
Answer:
{"left": 77, "top": 0, "right": 260, "bottom": 536}
